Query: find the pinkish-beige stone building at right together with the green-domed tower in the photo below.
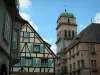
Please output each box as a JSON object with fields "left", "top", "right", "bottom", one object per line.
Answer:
{"left": 55, "top": 11, "right": 100, "bottom": 75}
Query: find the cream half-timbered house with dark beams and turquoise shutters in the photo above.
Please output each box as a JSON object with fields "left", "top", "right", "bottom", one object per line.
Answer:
{"left": 11, "top": 23, "right": 56, "bottom": 75}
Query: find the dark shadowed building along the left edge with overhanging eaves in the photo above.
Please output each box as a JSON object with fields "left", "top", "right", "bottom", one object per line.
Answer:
{"left": 0, "top": 0, "right": 25, "bottom": 75}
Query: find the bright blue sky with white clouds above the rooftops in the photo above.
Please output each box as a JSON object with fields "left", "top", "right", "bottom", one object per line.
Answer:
{"left": 19, "top": 0, "right": 100, "bottom": 53}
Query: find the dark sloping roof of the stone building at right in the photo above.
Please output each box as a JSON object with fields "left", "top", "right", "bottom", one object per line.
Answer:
{"left": 65, "top": 23, "right": 100, "bottom": 51}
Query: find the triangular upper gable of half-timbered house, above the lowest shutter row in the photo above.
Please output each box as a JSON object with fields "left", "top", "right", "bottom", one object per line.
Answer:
{"left": 20, "top": 24, "right": 56, "bottom": 58}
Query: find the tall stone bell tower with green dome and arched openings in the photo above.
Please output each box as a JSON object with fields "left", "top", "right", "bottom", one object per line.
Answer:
{"left": 56, "top": 9, "right": 77, "bottom": 54}
